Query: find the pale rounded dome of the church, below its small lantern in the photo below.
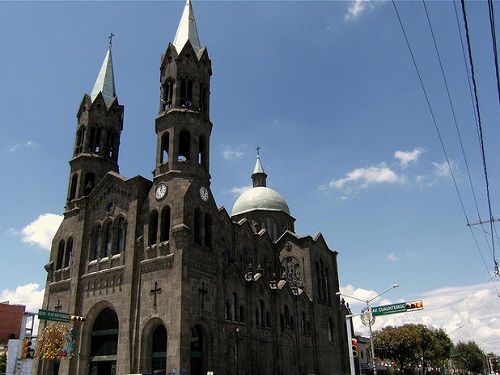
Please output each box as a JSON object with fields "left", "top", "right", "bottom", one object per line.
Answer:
{"left": 232, "top": 186, "right": 290, "bottom": 216}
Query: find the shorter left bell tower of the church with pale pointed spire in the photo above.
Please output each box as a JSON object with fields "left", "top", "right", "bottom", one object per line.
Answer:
{"left": 66, "top": 40, "right": 123, "bottom": 210}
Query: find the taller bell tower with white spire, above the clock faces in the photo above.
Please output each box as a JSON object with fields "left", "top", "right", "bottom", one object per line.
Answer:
{"left": 154, "top": 0, "right": 212, "bottom": 184}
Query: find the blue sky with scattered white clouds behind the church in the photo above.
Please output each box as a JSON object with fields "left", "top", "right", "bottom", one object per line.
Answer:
{"left": 0, "top": 1, "right": 500, "bottom": 352}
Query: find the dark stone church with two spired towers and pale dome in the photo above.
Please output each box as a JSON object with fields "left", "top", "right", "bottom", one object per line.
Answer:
{"left": 33, "top": 0, "right": 349, "bottom": 375}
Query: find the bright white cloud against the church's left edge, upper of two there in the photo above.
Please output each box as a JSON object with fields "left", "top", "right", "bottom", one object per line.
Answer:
{"left": 9, "top": 214, "right": 63, "bottom": 250}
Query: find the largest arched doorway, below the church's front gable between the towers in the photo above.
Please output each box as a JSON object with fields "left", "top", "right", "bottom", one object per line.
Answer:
{"left": 89, "top": 308, "right": 118, "bottom": 375}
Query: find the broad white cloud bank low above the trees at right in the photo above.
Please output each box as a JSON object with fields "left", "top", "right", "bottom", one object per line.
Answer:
{"left": 341, "top": 283, "right": 500, "bottom": 352}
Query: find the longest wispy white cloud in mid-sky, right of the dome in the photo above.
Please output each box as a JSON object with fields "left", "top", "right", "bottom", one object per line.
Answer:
{"left": 329, "top": 163, "right": 405, "bottom": 189}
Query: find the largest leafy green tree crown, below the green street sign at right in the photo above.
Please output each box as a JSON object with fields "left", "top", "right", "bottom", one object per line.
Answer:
{"left": 374, "top": 324, "right": 453, "bottom": 370}
